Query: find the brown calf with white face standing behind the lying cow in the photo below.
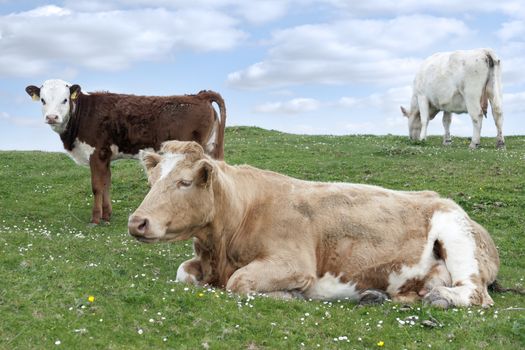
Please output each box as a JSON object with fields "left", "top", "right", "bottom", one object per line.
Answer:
{"left": 26, "top": 79, "right": 226, "bottom": 224}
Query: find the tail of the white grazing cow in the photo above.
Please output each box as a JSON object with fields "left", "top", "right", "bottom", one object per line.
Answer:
{"left": 481, "top": 49, "right": 502, "bottom": 117}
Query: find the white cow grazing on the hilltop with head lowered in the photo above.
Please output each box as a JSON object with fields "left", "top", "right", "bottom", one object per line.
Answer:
{"left": 401, "top": 49, "right": 505, "bottom": 148}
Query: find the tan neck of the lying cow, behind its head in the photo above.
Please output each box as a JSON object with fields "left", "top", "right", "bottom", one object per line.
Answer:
{"left": 194, "top": 162, "right": 287, "bottom": 287}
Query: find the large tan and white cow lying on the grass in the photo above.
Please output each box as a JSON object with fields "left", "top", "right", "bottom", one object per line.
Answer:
{"left": 128, "top": 141, "right": 499, "bottom": 307}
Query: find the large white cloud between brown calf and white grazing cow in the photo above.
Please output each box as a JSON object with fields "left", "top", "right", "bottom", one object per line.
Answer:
{"left": 228, "top": 15, "right": 472, "bottom": 88}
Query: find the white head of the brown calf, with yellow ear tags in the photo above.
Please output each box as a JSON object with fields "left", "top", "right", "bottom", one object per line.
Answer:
{"left": 26, "top": 79, "right": 80, "bottom": 133}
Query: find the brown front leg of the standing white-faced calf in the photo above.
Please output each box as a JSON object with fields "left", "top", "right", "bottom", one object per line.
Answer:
{"left": 89, "top": 152, "right": 111, "bottom": 224}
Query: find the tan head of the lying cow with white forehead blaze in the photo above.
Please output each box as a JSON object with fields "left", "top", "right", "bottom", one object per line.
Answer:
{"left": 128, "top": 141, "right": 215, "bottom": 243}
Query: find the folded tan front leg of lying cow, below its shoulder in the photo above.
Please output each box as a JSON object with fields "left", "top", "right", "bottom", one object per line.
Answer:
{"left": 226, "top": 259, "right": 315, "bottom": 297}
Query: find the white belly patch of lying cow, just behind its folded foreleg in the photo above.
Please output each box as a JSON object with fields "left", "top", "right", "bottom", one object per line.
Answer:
{"left": 304, "top": 272, "right": 359, "bottom": 300}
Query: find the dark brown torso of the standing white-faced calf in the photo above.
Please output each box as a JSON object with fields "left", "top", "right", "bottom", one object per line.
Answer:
{"left": 73, "top": 93, "right": 215, "bottom": 155}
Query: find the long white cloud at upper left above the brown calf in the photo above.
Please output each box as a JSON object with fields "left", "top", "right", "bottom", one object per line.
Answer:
{"left": 0, "top": 5, "right": 246, "bottom": 76}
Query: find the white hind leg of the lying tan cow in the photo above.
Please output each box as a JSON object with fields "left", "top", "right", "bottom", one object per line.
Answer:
{"left": 422, "top": 209, "right": 493, "bottom": 308}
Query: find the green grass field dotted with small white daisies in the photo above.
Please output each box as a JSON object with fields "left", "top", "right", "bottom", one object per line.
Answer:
{"left": 0, "top": 127, "right": 525, "bottom": 349}
